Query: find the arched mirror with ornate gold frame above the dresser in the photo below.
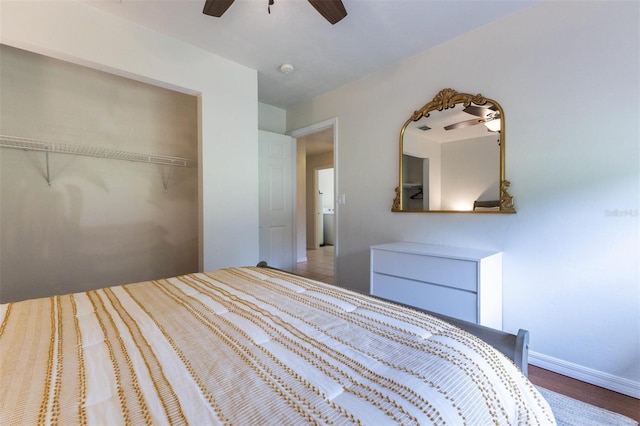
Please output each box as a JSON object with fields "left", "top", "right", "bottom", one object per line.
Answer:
{"left": 391, "top": 89, "right": 516, "bottom": 213}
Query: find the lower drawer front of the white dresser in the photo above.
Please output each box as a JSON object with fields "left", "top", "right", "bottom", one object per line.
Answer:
{"left": 371, "top": 272, "right": 478, "bottom": 323}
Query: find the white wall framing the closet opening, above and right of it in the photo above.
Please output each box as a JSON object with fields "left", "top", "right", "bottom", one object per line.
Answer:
{"left": 0, "top": 1, "right": 258, "bottom": 270}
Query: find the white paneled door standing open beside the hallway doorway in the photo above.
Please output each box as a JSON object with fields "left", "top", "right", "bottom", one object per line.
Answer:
{"left": 258, "top": 130, "right": 295, "bottom": 271}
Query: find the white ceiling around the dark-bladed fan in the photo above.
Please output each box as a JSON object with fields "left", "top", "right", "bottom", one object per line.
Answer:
{"left": 87, "top": 0, "right": 539, "bottom": 108}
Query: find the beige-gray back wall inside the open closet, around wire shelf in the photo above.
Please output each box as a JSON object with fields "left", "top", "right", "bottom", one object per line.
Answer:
{"left": 0, "top": 45, "right": 198, "bottom": 303}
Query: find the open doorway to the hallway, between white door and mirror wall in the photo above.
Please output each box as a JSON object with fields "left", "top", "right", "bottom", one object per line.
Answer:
{"left": 290, "top": 119, "right": 339, "bottom": 282}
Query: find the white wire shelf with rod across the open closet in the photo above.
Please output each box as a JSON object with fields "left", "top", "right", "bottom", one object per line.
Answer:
{"left": 0, "top": 135, "right": 197, "bottom": 167}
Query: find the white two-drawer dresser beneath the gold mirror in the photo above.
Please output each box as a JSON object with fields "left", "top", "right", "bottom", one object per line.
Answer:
{"left": 370, "top": 242, "right": 502, "bottom": 330}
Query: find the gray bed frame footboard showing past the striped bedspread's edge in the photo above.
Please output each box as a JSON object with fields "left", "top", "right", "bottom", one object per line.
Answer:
{"left": 257, "top": 261, "right": 529, "bottom": 377}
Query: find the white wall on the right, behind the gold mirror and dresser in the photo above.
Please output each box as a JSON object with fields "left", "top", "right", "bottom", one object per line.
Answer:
{"left": 287, "top": 2, "right": 640, "bottom": 396}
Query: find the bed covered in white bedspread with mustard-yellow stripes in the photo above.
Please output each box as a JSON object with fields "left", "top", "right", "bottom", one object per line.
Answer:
{"left": 0, "top": 267, "right": 555, "bottom": 425}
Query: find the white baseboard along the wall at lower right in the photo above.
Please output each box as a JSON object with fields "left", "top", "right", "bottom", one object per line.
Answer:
{"left": 529, "top": 351, "right": 640, "bottom": 398}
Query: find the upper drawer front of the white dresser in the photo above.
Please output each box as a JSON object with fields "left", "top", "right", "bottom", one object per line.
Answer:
{"left": 371, "top": 250, "right": 478, "bottom": 292}
